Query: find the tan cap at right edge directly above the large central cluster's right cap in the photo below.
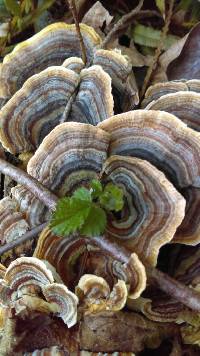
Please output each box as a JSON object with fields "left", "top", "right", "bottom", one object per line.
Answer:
{"left": 146, "top": 91, "right": 200, "bottom": 131}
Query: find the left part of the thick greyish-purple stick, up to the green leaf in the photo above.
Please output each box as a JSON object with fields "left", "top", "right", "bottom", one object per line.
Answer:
{"left": 0, "top": 158, "right": 57, "bottom": 210}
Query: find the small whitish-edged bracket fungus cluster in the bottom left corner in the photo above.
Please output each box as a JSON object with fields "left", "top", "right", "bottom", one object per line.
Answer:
{"left": 0, "top": 257, "right": 78, "bottom": 328}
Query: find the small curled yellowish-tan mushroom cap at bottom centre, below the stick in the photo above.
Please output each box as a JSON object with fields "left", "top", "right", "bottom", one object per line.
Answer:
{"left": 77, "top": 274, "right": 128, "bottom": 312}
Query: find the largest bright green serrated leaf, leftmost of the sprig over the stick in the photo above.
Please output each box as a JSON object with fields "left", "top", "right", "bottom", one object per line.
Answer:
{"left": 50, "top": 198, "right": 91, "bottom": 236}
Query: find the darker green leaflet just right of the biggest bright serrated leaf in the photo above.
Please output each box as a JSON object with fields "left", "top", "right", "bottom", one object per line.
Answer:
{"left": 80, "top": 204, "right": 107, "bottom": 237}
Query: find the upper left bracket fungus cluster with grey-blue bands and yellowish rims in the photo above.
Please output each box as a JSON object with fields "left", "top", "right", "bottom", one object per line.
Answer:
{"left": 0, "top": 23, "right": 138, "bottom": 154}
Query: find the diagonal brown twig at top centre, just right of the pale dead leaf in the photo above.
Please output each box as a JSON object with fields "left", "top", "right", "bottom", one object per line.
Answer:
{"left": 101, "top": 0, "right": 144, "bottom": 48}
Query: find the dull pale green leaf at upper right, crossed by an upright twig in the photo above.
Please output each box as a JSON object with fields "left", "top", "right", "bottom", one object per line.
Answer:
{"left": 133, "top": 24, "right": 180, "bottom": 50}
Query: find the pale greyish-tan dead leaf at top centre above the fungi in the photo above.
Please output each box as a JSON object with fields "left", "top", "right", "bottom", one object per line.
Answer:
{"left": 82, "top": 1, "right": 113, "bottom": 29}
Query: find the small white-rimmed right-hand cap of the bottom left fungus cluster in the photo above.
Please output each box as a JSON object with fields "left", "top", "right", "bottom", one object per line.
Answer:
{"left": 42, "top": 283, "right": 78, "bottom": 328}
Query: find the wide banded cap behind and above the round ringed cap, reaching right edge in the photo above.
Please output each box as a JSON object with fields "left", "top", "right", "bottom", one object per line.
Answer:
{"left": 98, "top": 110, "right": 200, "bottom": 188}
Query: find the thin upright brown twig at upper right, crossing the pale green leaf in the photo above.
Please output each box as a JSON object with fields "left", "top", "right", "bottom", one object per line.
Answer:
{"left": 140, "top": 0, "right": 174, "bottom": 100}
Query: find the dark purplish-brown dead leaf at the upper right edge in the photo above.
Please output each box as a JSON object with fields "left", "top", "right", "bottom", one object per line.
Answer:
{"left": 167, "top": 23, "right": 200, "bottom": 80}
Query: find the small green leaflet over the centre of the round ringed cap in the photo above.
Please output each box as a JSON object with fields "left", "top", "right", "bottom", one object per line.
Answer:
{"left": 99, "top": 183, "right": 124, "bottom": 211}
